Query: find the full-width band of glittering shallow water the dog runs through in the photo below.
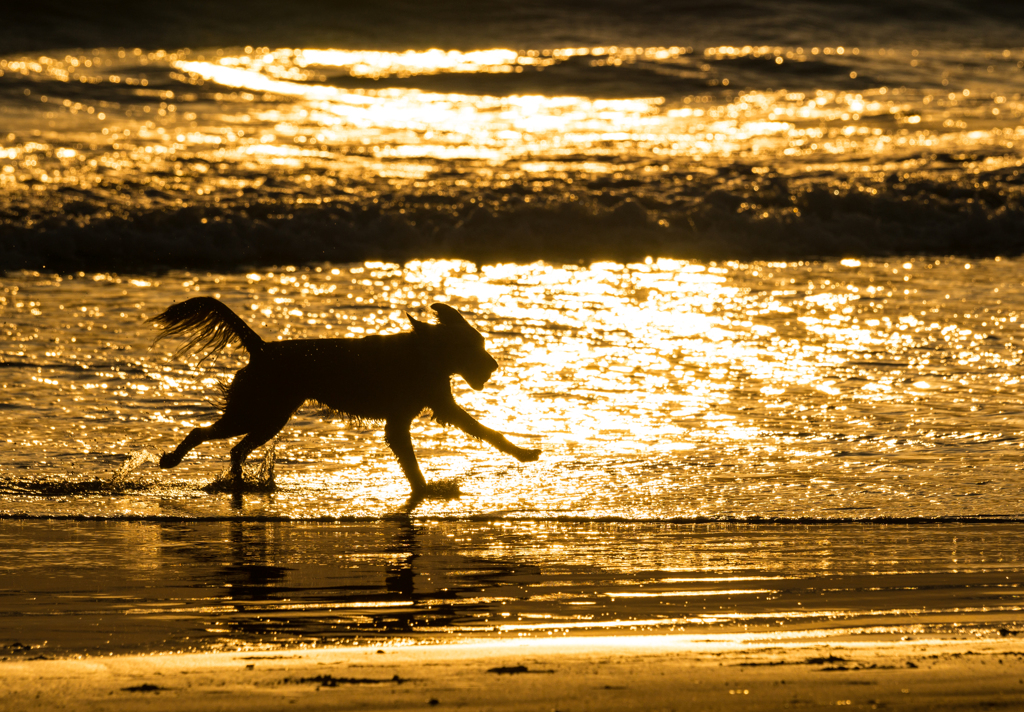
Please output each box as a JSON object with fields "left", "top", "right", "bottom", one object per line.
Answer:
{"left": 0, "top": 259, "right": 1024, "bottom": 521}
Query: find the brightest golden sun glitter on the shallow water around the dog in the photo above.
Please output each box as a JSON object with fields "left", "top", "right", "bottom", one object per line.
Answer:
{"left": 37, "top": 253, "right": 999, "bottom": 516}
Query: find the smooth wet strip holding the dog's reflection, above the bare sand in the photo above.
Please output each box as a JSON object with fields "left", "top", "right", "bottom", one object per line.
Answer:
{"left": 0, "top": 518, "right": 1024, "bottom": 655}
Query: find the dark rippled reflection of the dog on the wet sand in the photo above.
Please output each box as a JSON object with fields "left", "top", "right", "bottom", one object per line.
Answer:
{"left": 148, "top": 516, "right": 536, "bottom": 647}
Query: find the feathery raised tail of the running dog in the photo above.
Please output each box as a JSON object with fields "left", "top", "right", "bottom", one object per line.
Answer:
{"left": 150, "top": 297, "right": 263, "bottom": 360}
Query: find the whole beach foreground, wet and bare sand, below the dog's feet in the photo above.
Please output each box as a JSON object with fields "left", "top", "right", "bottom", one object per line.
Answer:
{"left": 0, "top": 520, "right": 1024, "bottom": 711}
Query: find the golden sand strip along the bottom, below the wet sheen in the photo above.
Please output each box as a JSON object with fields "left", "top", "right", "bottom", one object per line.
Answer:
{"left": 0, "top": 635, "right": 1024, "bottom": 712}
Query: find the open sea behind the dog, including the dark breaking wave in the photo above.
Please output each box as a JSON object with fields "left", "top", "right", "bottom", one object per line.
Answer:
{"left": 0, "top": 0, "right": 1024, "bottom": 271}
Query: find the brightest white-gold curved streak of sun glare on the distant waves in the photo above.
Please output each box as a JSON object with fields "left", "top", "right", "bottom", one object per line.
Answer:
{"left": 159, "top": 47, "right": 1019, "bottom": 166}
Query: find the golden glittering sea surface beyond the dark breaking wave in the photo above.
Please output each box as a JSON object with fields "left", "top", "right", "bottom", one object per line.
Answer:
{"left": 6, "top": 40, "right": 1024, "bottom": 250}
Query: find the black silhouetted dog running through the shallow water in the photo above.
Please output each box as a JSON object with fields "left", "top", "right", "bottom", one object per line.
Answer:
{"left": 151, "top": 297, "right": 541, "bottom": 495}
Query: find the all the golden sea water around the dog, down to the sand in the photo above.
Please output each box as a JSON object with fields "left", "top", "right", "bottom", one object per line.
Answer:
{"left": 0, "top": 0, "right": 1024, "bottom": 656}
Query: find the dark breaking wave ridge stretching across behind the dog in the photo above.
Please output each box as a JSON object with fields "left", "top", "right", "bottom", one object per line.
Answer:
{"left": 8, "top": 169, "right": 1024, "bottom": 271}
